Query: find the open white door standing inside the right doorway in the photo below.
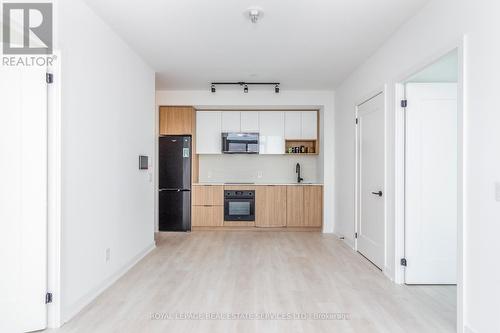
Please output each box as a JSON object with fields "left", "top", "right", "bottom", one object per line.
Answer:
{"left": 405, "top": 83, "right": 458, "bottom": 284}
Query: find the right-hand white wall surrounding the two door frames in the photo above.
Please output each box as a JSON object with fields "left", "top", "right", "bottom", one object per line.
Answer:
{"left": 335, "top": 0, "right": 500, "bottom": 332}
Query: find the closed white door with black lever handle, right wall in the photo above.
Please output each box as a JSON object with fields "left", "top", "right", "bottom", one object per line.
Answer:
{"left": 356, "top": 93, "right": 385, "bottom": 269}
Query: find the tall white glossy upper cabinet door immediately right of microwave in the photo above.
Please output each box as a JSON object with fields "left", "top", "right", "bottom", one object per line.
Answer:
{"left": 259, "top": 111, "right": 285, "bottom": 154}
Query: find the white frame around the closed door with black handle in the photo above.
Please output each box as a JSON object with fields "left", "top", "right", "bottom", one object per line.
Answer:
{"left": 354, "top": 90, "right": 387, "bottom": 275}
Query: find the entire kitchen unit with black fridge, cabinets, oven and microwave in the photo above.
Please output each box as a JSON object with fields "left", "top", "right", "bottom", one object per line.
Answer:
{"left": 158, "top": 106, "right": 323, "bottom": 231}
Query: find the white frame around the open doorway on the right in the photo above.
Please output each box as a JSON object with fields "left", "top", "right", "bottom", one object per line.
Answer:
{"left": 394, "top": 42, "right": 467, "bottom": 332}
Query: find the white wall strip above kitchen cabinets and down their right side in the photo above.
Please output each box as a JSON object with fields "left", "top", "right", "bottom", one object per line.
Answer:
{"left": 156, "top": 86, "right": 335, "bottom": 232}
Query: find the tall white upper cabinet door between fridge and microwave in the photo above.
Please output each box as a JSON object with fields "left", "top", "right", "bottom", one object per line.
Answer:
{"left": 196, "top": 111, "right": 222, "bottom": 154}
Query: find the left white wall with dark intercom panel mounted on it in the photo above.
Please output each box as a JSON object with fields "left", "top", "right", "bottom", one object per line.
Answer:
{"left": 55, "top": 0, "right": 155, "bottom": 321}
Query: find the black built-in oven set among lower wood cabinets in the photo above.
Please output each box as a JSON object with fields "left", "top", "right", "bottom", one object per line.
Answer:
{"left": 224, "top": 190, "right": 255, "bottom": 221}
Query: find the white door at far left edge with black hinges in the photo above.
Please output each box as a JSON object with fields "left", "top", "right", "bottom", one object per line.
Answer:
{"left": 0, "top": 67, "right": 47, "bottom": 332}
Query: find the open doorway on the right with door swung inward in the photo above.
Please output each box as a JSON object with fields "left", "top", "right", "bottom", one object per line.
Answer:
{"left": 396, "top": 49, "right": 462, "bottom": 322}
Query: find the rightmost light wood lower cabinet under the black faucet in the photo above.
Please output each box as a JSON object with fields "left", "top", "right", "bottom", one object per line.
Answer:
{"left": 286, "top": 185, "right": 323, "bottom": 227}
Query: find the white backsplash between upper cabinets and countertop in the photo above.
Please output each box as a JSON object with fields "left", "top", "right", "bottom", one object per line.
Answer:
{"left": 199, "top": 154, "right": 323, "bottom": 183}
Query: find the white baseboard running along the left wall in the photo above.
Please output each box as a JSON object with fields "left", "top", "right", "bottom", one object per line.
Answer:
{"left": 62, "top": 242, "right": 156, "bottom": 324}
